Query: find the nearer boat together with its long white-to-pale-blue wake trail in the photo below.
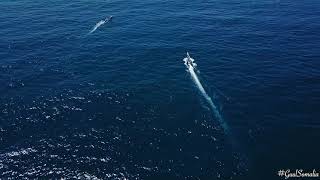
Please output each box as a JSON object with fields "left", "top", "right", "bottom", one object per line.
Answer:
{"left": 183, "top": 53, "right": 229, "bottom": 134}
